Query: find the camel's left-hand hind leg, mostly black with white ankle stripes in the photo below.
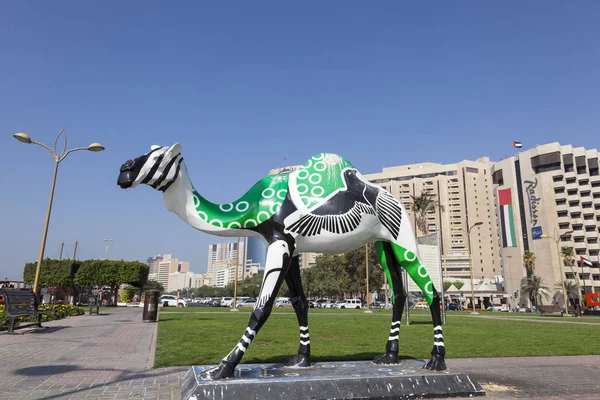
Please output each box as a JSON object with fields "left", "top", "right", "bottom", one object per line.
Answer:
{"left": 373, "top": 242, "right": 406, "bottom": 364}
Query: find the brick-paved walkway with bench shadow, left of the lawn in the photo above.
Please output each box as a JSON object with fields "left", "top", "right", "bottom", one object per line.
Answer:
{"left": 0, "top": 308, "right": 185, "bottom": 400}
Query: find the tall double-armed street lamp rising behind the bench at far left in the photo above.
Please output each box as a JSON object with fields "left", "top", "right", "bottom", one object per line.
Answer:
{"left": 13, "top": 129, "right": 104, "bottom": 295}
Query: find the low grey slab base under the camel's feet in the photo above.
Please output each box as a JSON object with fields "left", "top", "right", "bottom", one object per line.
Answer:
{"left": 181, "top": 360, "right": 485, "bottom": 400}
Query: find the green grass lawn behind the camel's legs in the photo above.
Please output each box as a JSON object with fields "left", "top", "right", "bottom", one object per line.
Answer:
{"left": 154, "top": 307, "right": 600, "bottom": 368}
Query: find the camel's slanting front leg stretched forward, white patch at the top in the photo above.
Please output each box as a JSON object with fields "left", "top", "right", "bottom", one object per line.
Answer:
{"left": 202, "top": 240, "right": 293, "bottom": 380}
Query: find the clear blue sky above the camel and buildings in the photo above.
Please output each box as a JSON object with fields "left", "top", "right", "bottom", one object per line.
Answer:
{"left": 0, "top": 1, "right": 600, "bottom": 278}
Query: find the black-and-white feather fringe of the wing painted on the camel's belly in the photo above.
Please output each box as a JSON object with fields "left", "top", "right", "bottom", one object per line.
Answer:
{"left": 287, "top": 201, "right": 375, "bottom": 236}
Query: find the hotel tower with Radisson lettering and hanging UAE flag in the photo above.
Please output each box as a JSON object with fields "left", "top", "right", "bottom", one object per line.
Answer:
{"left": 492, "top": 143, "right": 600, "bottom": 304}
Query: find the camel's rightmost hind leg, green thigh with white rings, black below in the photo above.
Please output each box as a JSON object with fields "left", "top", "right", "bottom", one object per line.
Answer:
{"left": 391, "top": 243, "right": 446, "bottom": 371}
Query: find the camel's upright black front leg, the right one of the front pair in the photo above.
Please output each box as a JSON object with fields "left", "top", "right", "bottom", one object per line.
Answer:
{"left": 284, "top": 256, "right": 310, "bottom": 367}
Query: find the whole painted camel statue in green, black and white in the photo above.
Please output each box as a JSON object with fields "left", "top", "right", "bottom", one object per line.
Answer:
{"left": 117, "top": 143, "right": 446, "bottom": 379}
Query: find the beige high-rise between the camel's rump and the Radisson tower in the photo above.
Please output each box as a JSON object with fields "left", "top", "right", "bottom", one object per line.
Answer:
{"left": 365, "top": 157, "right": 501, "bottom": 278}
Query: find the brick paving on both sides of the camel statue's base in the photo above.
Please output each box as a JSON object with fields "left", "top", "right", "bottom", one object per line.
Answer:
{"left": 0, "top": 308, "right": 600, "bottom": 400}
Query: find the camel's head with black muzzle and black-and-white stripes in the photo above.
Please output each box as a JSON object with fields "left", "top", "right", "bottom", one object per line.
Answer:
{"left": 117, "top": 143, "right": 183, "bottom": 192}
